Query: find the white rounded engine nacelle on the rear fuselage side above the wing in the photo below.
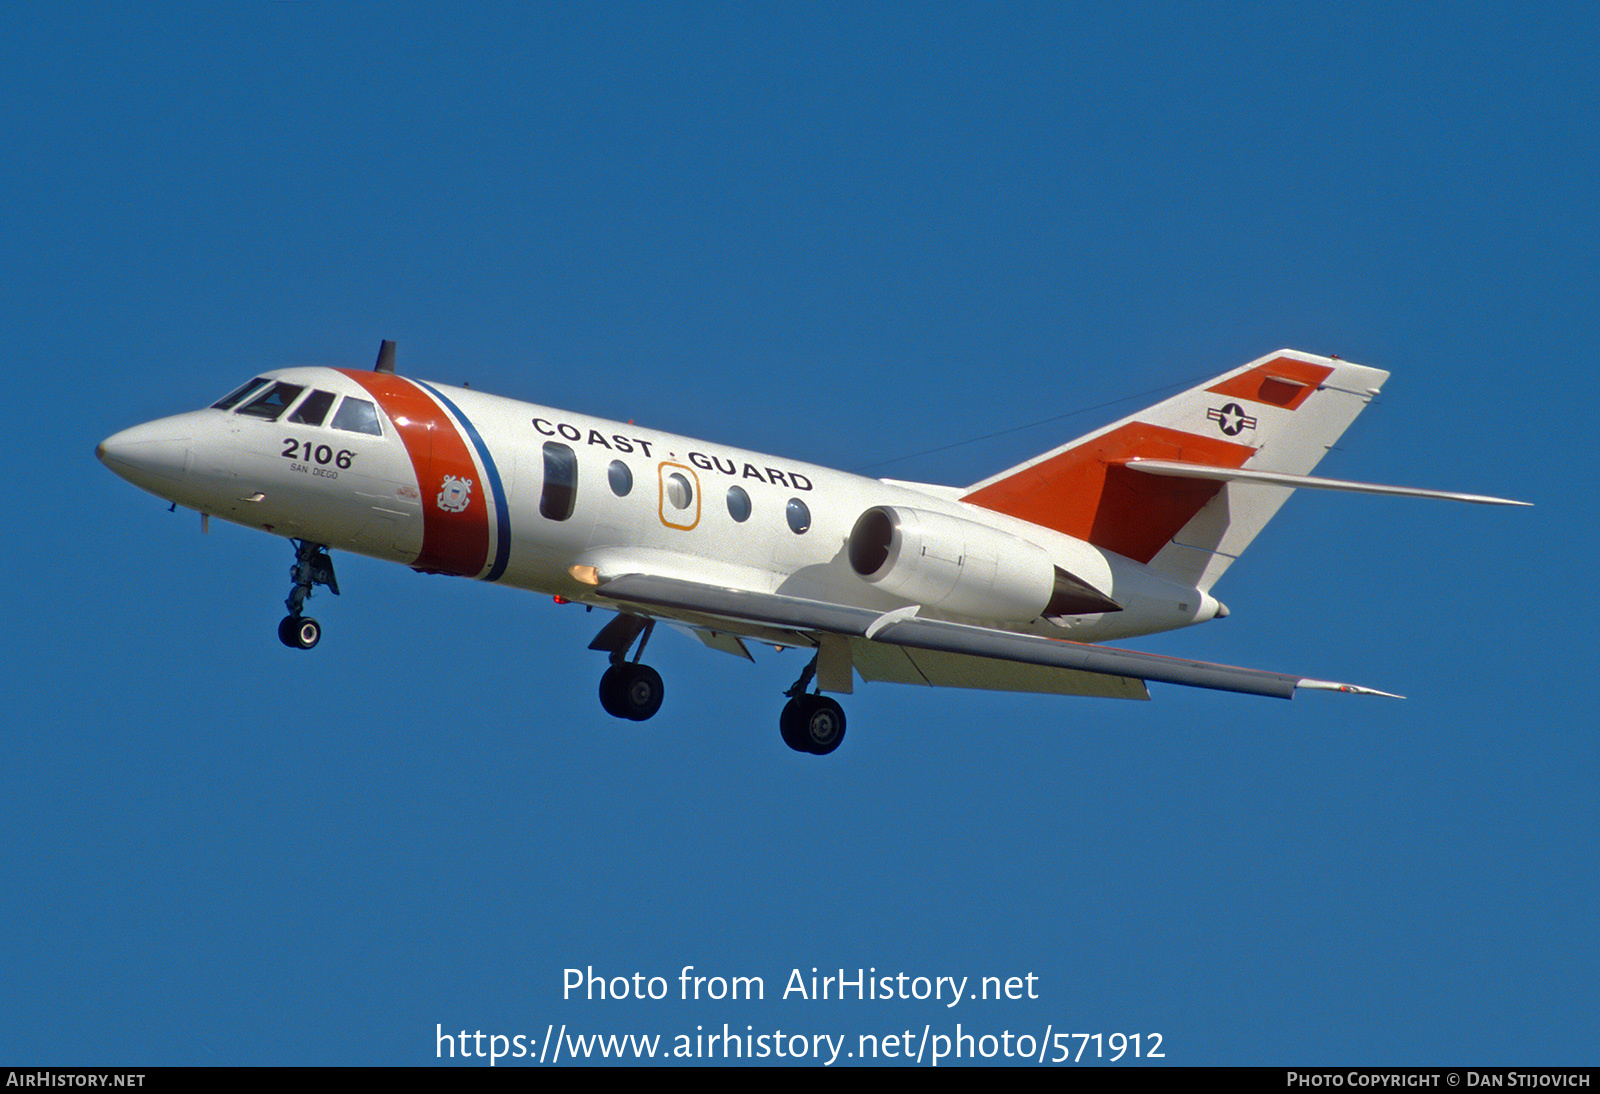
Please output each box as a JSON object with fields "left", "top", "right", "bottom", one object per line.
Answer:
{"left": 848, "top": 505, "right": 1056, "bottom": 622}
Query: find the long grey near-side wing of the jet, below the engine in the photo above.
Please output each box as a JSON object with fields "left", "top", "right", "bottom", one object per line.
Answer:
{"left": 597, "top": 574, "right": 1398, "bottom": 699}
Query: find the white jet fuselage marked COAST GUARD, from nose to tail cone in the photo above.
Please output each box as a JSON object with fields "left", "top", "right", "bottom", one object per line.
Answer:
{"left": 99, "top": 368, "right": 1219, "bottom": 640}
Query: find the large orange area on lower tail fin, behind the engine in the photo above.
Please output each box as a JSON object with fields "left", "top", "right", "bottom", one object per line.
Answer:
{"left": 962, "top": 422, "right": 1256, "bottom": 563}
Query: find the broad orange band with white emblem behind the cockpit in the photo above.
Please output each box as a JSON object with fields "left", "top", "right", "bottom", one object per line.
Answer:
{"left": 339, "top": 368, "right": 490, "bottom": 577}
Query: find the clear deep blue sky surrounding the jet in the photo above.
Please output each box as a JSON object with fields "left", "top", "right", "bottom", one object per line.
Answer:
{"left": 0, "top": 3, "right": 1600, "bottom": 1065}
